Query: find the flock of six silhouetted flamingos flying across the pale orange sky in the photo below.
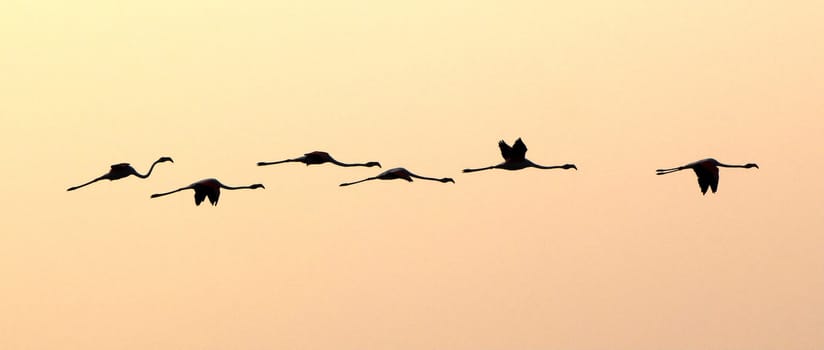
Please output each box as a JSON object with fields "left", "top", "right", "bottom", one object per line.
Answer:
{"left": 67, "top": 138, "right": 758, "bottom": 205}
